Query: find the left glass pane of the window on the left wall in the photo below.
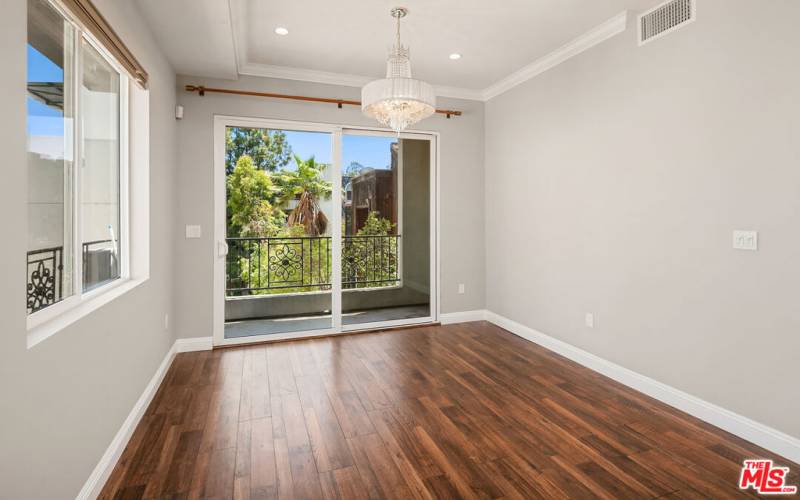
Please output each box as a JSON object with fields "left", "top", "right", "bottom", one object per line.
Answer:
{"left": 26, "top": 0, "right": 75, "bottom": 314}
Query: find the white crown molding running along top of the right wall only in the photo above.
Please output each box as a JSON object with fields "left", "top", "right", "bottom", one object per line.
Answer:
{"left": 482, "top": 10, "right": 628, "bottom": 101}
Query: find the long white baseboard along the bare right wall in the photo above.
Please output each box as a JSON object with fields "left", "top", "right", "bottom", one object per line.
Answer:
{"left": 486, "top": 311, "right": 800, "bottom": 462}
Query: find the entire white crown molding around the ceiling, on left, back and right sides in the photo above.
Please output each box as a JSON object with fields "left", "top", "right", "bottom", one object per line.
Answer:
{"left": 231, "top": 10, "right": 628, "bottom": 101}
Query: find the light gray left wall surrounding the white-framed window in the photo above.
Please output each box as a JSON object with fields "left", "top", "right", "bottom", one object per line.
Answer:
{"left": 0, "top": 0, "right": 176, "bottom": 500}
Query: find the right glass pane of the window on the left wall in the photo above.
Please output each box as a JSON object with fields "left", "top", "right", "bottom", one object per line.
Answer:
{"left": 80, "top": 40, "right": 123, "bottom": 291}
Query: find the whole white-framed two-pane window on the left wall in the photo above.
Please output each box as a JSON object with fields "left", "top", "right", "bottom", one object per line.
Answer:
{"left": 26, "top": 0, "right": 130, "bottom": 324}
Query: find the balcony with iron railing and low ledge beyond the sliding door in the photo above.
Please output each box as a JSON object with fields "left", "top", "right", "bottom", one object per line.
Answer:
{"left": 225, "top": 235, "right": 429, "bottom": 337}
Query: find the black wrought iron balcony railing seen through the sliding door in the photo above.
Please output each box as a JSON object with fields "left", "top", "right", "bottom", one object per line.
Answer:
{"left": 225, "top": 235, "right": 400, "bottom": 296}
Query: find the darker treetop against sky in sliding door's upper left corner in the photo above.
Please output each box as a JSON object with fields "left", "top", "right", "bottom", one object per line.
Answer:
{"left": 225, "top": 127, "right": 292, "bottom": 175}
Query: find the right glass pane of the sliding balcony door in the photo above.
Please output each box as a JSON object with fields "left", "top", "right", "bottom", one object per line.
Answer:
{"left": 342, "top": 134, "right": 430, "bottom": 325}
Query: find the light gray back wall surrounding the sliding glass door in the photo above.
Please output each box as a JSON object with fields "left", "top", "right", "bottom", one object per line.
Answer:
{"left": 175, "top": 76, "right": 485, "bottom": 337}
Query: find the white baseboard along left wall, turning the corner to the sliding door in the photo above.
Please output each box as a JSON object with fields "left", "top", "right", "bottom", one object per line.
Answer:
{"left": 76, "top": 337, "right": 212, "bottom": 500}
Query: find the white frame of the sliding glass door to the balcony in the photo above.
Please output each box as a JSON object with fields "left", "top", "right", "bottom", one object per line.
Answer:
{"left": 210, "top": 115, "right": 440, "bottom": 347}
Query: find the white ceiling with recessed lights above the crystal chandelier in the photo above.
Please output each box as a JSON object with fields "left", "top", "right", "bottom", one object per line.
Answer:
{"left": 137, "top": 0, "right": 661, "bottom": 96}
